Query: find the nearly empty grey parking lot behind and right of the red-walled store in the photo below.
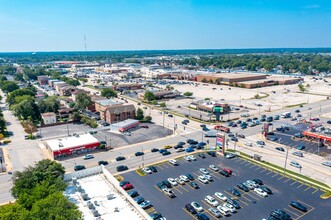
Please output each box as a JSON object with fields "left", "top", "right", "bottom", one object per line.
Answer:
{"left": 41, "top": 123, "right": 172, "bottom": 147}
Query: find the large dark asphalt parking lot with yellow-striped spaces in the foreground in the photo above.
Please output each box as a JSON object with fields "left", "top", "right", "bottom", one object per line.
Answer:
{"left": 122, "top": 155, "right": 331, "bottom": 220}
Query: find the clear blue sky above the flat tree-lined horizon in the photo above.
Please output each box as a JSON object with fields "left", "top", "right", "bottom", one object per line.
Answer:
{"left": 0, "top": 0, "right": 331, "bottom": 52}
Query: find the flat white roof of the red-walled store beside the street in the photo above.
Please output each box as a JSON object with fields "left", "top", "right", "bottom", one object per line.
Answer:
{"left": 46, "top": 133, "right": 99, "bottom": 152}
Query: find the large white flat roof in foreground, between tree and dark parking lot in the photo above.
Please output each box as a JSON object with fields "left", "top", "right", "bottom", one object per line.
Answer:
{"left": 64, "top": 168, "right": 147, "bottom": 220}
